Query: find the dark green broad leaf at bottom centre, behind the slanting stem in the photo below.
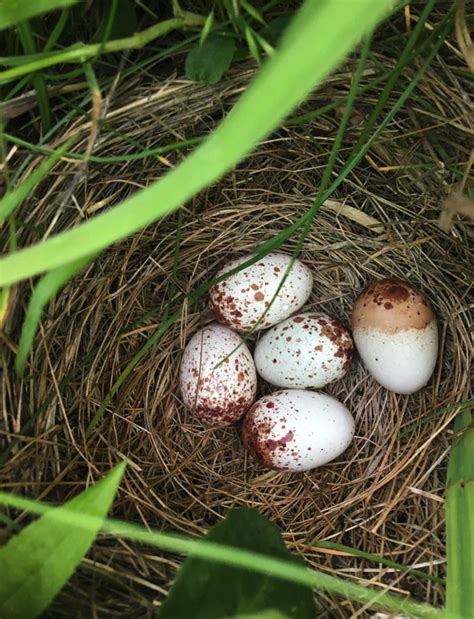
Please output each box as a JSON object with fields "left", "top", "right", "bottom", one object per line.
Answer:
{"left": 158, "top": 508, "right": 315, "bottom": 619}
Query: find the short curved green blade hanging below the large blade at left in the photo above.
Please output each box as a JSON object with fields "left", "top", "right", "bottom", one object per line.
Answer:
{"left": 15, "top": 256, "right": 95, "bottom": 377}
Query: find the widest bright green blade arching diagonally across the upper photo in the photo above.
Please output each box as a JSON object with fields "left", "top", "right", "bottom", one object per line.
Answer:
{"left": 0, "top": 0, "right": 392, "bottom": 285}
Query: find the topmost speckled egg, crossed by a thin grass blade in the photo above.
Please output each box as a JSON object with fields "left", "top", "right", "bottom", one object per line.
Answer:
{"left": 209, "top": 252, "right": 313, "bottom": 331}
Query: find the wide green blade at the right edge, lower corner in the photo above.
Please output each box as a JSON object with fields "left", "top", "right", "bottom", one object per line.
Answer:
{"left": 445, "top": 409, "right": 474, "bottom": 619}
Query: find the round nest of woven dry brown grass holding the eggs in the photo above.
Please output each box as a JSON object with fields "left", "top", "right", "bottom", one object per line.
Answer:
{"left": 0, "top": 34, "right": 471, "bottom": 618}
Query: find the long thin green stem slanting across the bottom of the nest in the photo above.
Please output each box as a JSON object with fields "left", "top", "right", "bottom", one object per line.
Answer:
{"left": 0, "top": 492, "right": 442, "bottom": 619}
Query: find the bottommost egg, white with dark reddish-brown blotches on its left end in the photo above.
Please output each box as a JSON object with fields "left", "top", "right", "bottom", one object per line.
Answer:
{"left": 243, "top": 389, "right": 354, "bottom": 471}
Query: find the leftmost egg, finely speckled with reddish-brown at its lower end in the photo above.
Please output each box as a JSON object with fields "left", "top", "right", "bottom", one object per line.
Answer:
{"left": 180, "top": 323, "right": 257, "bottom": 426}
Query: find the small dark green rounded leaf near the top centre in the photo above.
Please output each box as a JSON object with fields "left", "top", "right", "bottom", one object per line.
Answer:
{"left": 185, "top": 34, "right": 235, "bottom": 86}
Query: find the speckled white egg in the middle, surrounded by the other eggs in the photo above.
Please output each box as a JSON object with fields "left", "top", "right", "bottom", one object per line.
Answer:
{"left": 254, "top": 312, "right": 354, "bottom": 388}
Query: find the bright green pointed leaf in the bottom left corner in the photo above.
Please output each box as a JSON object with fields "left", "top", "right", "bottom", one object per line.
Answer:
{"left": 0, "top": 463, "right": 125, "bottom": 619}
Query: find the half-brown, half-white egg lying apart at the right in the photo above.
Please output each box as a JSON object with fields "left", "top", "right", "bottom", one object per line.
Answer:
{"left": 352, "top": 279, "right": 439, "bottom": 394}
